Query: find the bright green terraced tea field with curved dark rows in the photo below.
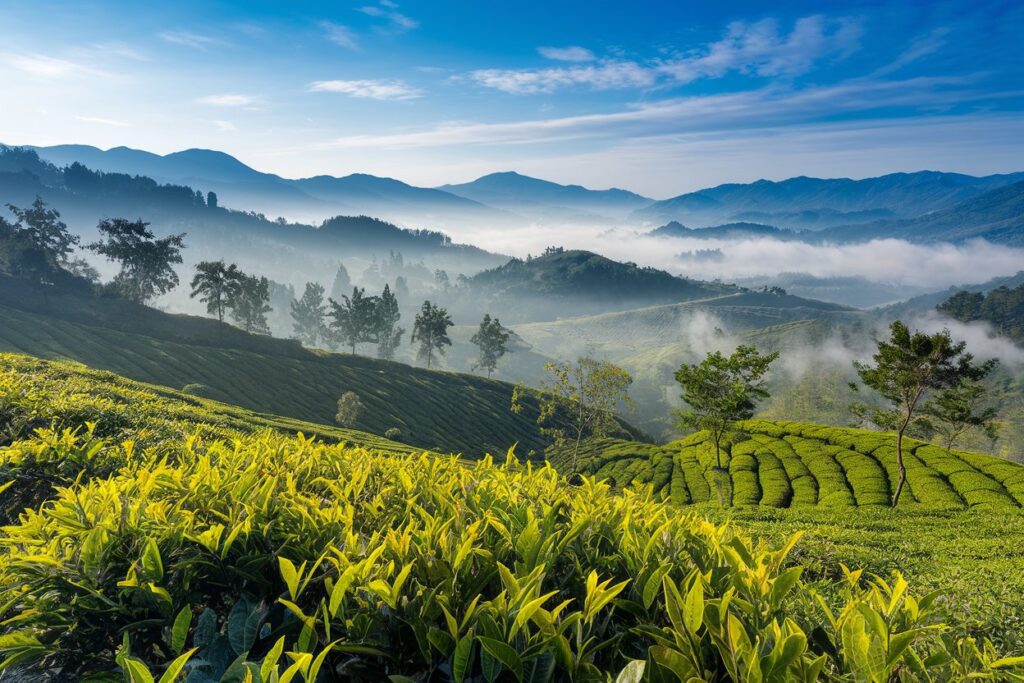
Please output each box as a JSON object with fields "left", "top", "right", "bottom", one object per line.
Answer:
{"left": 553, "top": 420, "right": 1024, "bottom": 509}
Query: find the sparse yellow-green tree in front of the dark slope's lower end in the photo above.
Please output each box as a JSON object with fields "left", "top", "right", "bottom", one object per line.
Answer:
{"left": 512, "top": 357, "right": 633, "bottom": 474}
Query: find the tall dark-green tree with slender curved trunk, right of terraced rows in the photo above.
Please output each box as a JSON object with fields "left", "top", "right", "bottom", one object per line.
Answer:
{"left": 853, "top": 321, "right": 994, "bottom": 507}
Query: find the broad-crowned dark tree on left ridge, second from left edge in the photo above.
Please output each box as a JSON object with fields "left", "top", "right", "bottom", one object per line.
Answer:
{"left": 88, "top": 218, "right": 185, "bottom": 303}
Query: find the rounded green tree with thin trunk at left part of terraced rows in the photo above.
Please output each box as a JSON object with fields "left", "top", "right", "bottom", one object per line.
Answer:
{"left": 676, "top": 346, "right": 778, "bottom": 503}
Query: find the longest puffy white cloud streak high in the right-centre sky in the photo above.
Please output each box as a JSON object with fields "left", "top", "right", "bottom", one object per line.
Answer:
{"left": 469, "top": 15, "right": 861, "bottom": 94}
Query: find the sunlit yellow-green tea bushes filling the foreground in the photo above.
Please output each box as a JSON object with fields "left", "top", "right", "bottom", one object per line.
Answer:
{"left": 0, "top": 355, "right": 1024, "bottom": 683}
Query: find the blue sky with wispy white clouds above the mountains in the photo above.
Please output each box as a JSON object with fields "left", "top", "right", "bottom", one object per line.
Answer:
{"left": 0, "top": 0, "right": 1024, "bottom": 198}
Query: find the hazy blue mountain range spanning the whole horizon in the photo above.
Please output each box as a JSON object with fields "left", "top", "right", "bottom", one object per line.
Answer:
{"left": 12, "top": 144, "right": 1024, "bottom": 245}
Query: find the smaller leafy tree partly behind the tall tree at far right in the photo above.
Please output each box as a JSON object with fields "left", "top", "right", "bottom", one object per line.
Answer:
{"left": 922, "top": 376, "right": 999, "bottom": 453}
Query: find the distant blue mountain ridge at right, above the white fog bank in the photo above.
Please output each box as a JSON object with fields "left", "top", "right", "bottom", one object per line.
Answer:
{"left": 633, "top": 171, "right": 1024, "bottom": 228}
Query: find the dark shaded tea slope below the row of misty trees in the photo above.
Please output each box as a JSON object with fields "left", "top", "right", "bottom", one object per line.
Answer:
{"left": 0, "top": 279, "right": 630, "bottom": 457}
